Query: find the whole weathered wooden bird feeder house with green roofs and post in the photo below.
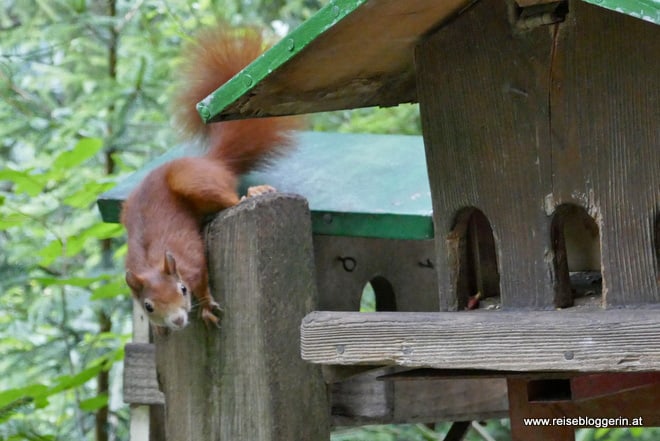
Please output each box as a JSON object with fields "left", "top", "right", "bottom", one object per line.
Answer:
{"left": 101, "top": 0, "right": 660, "bottom": 440}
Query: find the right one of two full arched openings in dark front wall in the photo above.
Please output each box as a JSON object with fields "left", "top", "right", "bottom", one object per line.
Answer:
{"left": 550, "top": 204, "right": 602, "bottom": 308}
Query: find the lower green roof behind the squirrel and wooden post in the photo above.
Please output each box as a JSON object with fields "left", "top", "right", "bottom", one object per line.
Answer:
{"left": 98, "top": 132, "right": 433, "bottom": 240}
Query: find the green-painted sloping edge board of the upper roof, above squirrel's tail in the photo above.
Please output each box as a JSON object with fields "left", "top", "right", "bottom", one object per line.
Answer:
{"left": 197, "top": 0, "right": 366, "bottom": 123}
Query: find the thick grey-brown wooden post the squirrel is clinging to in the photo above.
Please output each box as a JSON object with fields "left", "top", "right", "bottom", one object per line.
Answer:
{"left": 156, "top": 194, "right": 330, "bottom": 441}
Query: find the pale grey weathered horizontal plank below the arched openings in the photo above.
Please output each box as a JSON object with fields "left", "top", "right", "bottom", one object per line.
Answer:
{"left": 301, "top": 309, "right": 660, "bottom": 372}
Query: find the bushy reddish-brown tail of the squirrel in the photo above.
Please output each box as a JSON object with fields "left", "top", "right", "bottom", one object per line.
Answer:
{"left": 173, "top": 25, "right": 300, "bottom": 174}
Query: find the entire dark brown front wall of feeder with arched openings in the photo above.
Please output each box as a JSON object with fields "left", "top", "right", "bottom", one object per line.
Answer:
{"left": 416, "top": 0, "right": 660, "bottom": 310}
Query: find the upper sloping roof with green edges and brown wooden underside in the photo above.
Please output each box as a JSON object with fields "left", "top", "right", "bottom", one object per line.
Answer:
{"left": 198, "top": 0, "right": 660, "bottom": 122}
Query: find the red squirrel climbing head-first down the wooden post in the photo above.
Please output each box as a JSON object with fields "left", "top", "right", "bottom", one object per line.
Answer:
{"left": 121, "top": 26, "right": 298, "bottom": 331}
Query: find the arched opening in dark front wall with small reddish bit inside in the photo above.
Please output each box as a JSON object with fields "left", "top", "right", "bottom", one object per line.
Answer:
{"left": 447, "top": 208, "right": 500, "bottom": 309}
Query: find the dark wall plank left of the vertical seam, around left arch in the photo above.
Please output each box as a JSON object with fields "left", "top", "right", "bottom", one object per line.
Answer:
{"left": 415, "top": 0, "right": 553, "bottom": 310}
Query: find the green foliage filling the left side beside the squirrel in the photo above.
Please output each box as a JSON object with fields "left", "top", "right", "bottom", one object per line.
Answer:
{"left": 0, "top": 0, "right": 336, "bottom": 440}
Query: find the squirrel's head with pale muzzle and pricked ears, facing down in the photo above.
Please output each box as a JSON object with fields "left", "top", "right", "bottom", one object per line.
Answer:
{"left": 126, "top": 252, "right": 191, "bottom": 330}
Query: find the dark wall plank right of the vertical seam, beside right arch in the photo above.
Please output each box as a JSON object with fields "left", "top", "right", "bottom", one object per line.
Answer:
{"left": 549, "top": 1, "right": 660, "bottom": 306}
